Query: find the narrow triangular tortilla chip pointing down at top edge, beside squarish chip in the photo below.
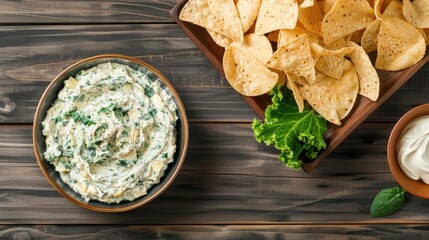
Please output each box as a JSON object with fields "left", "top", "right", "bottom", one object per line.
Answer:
{"left": 234, "top": 0, "right": 261, "bottom": 32}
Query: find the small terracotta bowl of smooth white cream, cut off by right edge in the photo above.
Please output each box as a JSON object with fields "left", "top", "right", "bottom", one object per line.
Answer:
{"left": 387, "top": 104, "right": 429, "bottom": 199}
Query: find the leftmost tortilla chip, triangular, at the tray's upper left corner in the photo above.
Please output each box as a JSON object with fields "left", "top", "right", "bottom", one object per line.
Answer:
{"left": 179, "top": 0, "right": 226, "bottom": 35}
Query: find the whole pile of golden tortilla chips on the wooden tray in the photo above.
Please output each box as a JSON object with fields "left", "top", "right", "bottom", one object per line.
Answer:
{"left": 179, "top": 0, "right": 429, "bottom": 125}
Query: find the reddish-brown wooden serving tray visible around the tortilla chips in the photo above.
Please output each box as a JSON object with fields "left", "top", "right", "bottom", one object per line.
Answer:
{"left": 170, "top": 0, "right": 429, "bottom": 173}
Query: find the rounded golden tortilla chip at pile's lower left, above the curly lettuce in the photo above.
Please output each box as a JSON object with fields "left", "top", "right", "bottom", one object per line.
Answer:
{"left": 223, "top": 46, "right": 278, "bottom": 96}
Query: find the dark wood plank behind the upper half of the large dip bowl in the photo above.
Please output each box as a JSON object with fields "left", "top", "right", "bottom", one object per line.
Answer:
{"left": 0, "top": 24, "right": 429, "bottom": 123}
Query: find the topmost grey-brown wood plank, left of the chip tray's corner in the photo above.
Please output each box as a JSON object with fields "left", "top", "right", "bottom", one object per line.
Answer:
{"left": 0, "top": 0, "right": 176, "bottom": 24}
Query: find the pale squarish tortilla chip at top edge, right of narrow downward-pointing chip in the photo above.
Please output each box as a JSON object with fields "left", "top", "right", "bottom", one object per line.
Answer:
{"left": 255, "top": 0, "right": 298, "bottom": 35}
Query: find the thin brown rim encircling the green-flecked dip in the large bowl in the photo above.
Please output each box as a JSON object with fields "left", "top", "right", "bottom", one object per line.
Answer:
{"left": 32, "top": 54, "right": 189, "bottom": 212}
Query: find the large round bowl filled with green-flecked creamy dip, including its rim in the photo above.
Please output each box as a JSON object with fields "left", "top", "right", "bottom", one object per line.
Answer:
{"left": 33, "top": 54, "right": 188, "bottom": 212}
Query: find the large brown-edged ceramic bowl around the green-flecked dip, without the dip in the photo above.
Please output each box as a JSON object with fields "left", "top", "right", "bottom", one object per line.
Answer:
{"left": 33, "top": 54, "right": 188, "bottom": 212}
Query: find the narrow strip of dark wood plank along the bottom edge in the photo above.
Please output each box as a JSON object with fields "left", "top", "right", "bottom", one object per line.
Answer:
{"left": 0, "top": 225, "right": 429, "bottom": 240}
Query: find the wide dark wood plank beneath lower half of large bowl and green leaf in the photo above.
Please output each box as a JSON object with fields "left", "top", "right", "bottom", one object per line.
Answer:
{"left": 0, "top": 124, "right": 422, "bottom": 224}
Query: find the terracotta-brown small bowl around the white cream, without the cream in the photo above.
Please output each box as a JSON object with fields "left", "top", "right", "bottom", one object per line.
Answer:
{"left": 387, "top": 103, "right": 429, "bottom": 199}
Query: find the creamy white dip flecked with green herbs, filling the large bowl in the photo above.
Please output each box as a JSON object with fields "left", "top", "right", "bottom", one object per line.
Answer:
{"left": 42, "top": 62, "right": 177, "bottom": 203}
